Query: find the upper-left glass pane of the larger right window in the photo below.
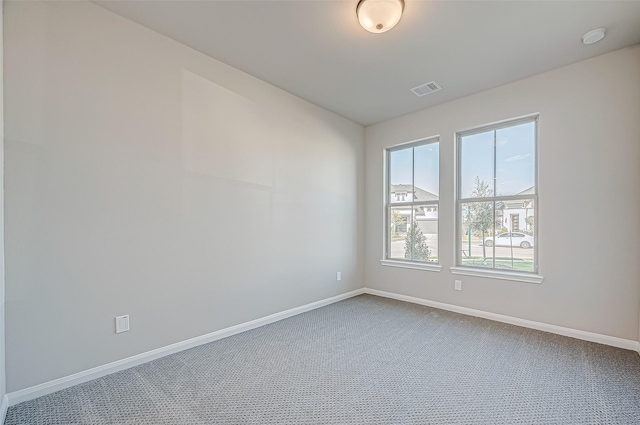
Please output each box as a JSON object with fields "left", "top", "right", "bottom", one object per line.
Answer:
{"left": 460, "top": 131, "right": 494, "bottom": 199}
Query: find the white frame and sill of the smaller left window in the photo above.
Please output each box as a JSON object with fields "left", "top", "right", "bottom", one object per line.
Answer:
{"left": 380, "top": 135, "right": 442, "bottom": 271}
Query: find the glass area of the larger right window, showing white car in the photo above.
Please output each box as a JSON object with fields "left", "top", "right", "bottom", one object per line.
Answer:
{"left": 457, "top": 117, "right": 538, "bottom": 272}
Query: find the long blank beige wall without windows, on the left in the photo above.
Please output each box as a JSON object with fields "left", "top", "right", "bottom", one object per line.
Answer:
{"left": 5, "top": 2, "right": 364, "bottom": 391}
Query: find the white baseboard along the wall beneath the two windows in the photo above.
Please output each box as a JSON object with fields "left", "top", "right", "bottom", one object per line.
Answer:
{"left": 364, "top": 288, "right": 640, "bottom": 353}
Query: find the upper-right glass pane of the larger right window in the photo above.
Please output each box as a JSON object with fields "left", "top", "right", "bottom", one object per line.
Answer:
{"left": 496, "top": 122, "right": 535, "bottom": 196}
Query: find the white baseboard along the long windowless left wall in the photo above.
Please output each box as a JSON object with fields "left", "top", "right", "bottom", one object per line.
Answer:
{"left": 5, "top": 289, "right": 364, "bottom": 404}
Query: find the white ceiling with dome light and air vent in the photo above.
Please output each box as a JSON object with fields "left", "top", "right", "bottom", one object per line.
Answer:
{"left": 95, "top": 0, "right": 640, "bottom": 125}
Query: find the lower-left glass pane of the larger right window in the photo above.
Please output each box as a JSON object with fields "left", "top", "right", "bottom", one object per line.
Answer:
{"left": 459, "top": 202, "right": 495, "bottom": 268}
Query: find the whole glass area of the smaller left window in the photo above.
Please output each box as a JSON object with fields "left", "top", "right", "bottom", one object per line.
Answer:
{"left": 385, "top": 138, "right": 440, "bottom": 263}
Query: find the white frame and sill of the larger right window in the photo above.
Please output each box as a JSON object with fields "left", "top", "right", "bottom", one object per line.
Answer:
{"left": 450, "top": 114, "right": 544, "bottom": 283}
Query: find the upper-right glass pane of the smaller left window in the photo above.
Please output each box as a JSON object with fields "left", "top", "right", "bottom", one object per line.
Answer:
{"left": 413, "top": 143, "right": 440, "bottom": 202}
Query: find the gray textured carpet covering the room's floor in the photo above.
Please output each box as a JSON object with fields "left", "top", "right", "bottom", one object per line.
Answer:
{"left": 6, "top": 295, "right": 640, "bottom": 425}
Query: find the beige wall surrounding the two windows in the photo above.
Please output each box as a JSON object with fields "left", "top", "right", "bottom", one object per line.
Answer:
{"left": 365, "top": 46, "right": 640, "bottom": 340}
